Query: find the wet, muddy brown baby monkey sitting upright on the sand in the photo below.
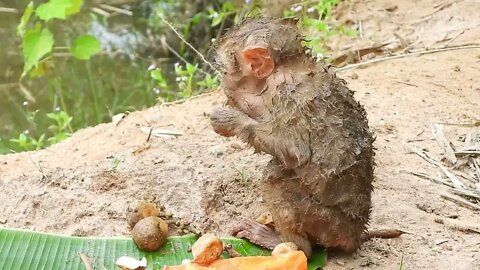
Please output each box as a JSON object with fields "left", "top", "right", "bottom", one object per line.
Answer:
{"left": 211, "top": 19, "right": 374, "bottom": 256}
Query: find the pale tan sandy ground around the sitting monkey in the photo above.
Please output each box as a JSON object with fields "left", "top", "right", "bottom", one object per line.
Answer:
{"left": 0, "top": 0, "right": 480, "bottom": 269}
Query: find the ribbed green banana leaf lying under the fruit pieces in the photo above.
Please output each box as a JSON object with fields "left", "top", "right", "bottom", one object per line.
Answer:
{"left": 0, "top": 228, "right": 326, "bottom": 270}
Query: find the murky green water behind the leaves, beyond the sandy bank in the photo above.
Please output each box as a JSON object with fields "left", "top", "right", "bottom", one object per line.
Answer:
{"left": 0, "top": 0, "right": 173, "bottom": 154}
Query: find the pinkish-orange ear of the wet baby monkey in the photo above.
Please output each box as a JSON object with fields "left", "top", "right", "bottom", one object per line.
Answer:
{"left": 243, "top": 47, "right": 275, "bottom": 79}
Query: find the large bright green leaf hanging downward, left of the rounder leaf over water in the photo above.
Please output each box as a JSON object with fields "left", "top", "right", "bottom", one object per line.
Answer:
{"left": 22, "top": 28, "right": 53, "bottom": 77}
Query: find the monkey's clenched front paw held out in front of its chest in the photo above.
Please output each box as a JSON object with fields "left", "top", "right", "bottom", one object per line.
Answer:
{"left": 210, "top": 108, "right": 243, "bottom": 137}
